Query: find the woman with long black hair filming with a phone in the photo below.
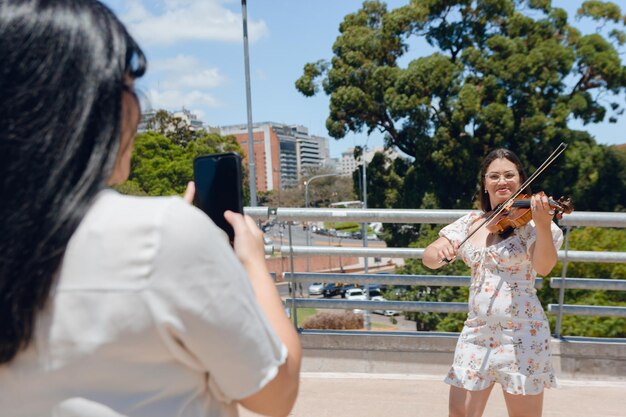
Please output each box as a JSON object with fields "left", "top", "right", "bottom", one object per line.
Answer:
{"left": 0, "top": 0, "right": 300, "bottom": 417}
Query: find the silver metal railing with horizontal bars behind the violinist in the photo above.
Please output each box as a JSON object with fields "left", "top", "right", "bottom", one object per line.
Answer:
{"left": 246, "top": 207, "right": 626, "bottom": 337}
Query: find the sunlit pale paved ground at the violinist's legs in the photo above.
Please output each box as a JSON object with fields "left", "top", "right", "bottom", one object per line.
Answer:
{"left": 236, "top": 373, "right": 626, "bottom": 417}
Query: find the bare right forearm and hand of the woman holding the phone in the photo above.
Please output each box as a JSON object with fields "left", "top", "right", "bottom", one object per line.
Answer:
{"left": 224, "top": 212, "right": 302, "bottom": 417}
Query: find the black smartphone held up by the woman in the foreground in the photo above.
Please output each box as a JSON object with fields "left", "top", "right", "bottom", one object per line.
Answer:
{"left": 193, "top": 152, "right": 243, "bottom": 243}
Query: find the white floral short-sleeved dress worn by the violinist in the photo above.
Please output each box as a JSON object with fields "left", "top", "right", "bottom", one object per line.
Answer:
{"left": 439, "top": 212, "right": 563, "bottom": 395}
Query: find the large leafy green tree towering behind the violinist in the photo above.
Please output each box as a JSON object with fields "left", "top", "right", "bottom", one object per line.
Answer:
{"left": 296, "top": 0, "right": 626, "bottom": 210}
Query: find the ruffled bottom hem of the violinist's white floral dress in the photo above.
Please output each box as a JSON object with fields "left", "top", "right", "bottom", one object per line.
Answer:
{"left": 444, "top": 366, "right": 560, "bottom": 395}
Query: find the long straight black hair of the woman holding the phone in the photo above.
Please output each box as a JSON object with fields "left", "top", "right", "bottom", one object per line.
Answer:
{"left": 0, "top": 0, "right": 146, "bottom": 364}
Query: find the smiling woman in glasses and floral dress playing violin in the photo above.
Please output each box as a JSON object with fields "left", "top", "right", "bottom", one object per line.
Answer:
{"left": 422, "top": 149, "right": 563, "bottom": 417}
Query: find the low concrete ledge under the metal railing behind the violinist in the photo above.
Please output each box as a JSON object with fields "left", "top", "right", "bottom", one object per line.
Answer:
{"left": 301, "top": 331, "right": 626, "bottom": 380}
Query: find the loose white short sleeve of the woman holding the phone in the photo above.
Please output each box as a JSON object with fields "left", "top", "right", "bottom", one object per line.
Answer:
{"left": 146, "top": 198, "right": 287, "bottom": 402}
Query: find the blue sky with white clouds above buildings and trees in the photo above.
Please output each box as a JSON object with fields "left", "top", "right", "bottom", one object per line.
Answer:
{"left": 104, "top": 0, "right": 626, "bottom": 157}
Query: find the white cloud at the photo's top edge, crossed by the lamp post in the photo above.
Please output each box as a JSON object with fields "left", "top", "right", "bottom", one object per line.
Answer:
{"left": 123, "top": 0, "right": 268, "bottom": 45}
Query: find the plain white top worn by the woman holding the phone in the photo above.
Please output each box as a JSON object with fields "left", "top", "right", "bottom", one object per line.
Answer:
{"left": 0, "top": 190, "right": 287, "bottom": 417}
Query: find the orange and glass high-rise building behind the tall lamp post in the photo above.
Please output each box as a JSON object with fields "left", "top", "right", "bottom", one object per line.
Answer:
{"left": 220, "top": 122, "right": 329, "bottom": 191}
